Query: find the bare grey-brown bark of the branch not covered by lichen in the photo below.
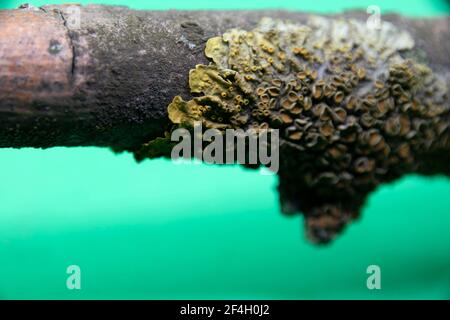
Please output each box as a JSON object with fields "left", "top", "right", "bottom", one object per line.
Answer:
{"left": 0, "top": 5, "right": 450, "bottom": 150}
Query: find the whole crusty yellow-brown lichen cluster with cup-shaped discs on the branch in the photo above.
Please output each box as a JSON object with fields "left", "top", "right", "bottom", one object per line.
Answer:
{"left": 139, "top": 17, "right": 449, "bottom": 243}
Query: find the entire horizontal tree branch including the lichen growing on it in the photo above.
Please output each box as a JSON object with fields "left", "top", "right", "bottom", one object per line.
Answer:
{"left": 0, "top": 5, "right": 450, "bottom": 243}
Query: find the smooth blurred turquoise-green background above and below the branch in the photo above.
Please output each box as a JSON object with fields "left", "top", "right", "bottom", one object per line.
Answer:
{"left": 0, "top": 0, "right": 450, "bottom": 299}
